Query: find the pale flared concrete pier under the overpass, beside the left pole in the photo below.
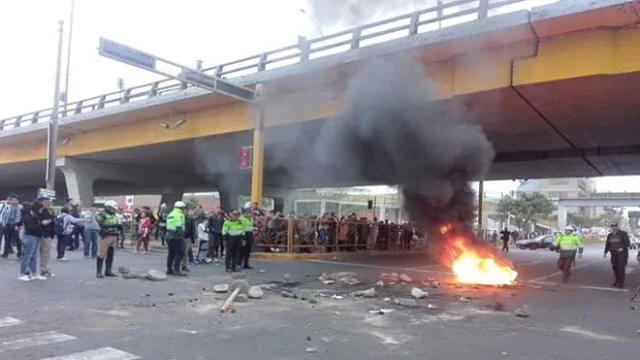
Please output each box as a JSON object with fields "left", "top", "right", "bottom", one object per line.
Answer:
{"left": 56, "top": 158, "right": 96, "bottom": 206}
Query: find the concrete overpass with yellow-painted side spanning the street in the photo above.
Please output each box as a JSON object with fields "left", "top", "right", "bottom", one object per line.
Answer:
{"left": 0, "top": 0, "right": 640, "bottom": 207}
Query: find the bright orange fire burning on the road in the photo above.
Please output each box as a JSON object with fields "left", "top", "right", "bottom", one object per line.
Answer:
{"left": 440, "top": 225, "right": 518, "bottom": 285}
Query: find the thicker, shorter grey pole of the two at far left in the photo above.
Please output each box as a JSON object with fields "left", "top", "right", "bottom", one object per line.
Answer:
{"left": 45, "top": 20, "right": 64, "bottom": 190}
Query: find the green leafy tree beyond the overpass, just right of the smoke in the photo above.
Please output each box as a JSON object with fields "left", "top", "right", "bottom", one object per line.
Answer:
{"left": 496, "top": 193, "right": 556, "bottom": 230}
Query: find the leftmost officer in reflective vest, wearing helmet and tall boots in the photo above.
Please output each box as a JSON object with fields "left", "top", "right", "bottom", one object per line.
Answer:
{"left": 96, "top": 200, "right": 122, "bottom": 279}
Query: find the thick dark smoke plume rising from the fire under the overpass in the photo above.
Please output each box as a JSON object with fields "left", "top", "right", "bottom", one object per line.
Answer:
{"left": 314, "top": 59, "right": 494, "bottom": 235}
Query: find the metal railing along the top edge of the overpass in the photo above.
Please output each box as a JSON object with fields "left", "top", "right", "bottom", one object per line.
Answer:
{"left": 0, "top": 0, "right": 527, "bottom": 132}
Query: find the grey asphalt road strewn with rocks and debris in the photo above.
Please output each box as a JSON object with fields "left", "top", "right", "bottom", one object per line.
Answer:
{"left": 0, "top": 243, "right": 640, "bottom": 360}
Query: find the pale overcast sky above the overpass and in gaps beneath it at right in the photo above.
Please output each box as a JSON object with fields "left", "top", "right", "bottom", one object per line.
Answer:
{"left": 0, "top": 0, "right": 640, "bottom": 192}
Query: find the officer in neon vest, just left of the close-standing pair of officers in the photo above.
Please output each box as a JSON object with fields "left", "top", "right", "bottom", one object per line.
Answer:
{"left": 165, "top": 201, "right": 187, "bottom": 276}
